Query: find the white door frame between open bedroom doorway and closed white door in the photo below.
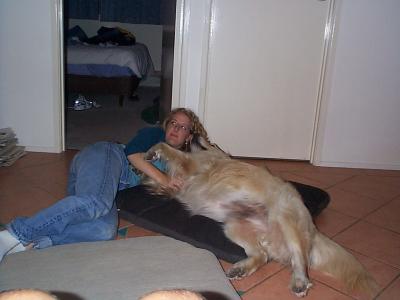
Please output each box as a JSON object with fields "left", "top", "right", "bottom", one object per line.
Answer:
{"left": 172, "top": 0, "right": 213, "bottom": 121}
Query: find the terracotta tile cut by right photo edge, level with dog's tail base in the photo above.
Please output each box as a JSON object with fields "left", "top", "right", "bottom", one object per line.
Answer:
{"left": 334, "top": 221, "right": 400, "bottom": 268}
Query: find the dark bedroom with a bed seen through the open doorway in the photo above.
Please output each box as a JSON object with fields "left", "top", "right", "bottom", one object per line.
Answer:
{"left": 63, "top": 0, "right": 176, "bottom": 149}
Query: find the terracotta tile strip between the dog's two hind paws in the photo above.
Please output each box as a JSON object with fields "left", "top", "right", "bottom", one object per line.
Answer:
{"left": 220, "top": 260, "right": 284, "bottom": 292}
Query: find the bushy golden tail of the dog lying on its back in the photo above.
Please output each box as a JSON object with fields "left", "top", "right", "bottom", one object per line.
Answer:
{"left": 310, "top": 232, "right": 379, "bottom": 296}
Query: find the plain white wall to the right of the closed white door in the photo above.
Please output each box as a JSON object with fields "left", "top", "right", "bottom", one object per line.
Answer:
{"left": 315, "top": 0, "right": 400, "bottom": 169}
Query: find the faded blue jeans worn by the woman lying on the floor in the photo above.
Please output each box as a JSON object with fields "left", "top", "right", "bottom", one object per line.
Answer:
{"left": 6, "top": 142, "right": 139, "bottom": 249}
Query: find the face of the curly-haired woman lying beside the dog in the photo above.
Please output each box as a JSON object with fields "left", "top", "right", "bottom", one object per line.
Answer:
{"left": 165, "top": 112, "right": 192, "bottom": 149}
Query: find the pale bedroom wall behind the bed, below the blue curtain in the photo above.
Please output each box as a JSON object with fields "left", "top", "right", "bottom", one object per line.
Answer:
{"left": 68, "top": 19, "right": 163, "bottom": 71}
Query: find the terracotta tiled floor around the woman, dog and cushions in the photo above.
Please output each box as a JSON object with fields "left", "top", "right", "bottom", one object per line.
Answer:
{"left": 0, "top": 151, "right": 400, "bottom": 300}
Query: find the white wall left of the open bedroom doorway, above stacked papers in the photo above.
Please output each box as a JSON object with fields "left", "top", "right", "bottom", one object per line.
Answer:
{"left": 0, "top": 0, "right": 62, "bottom": 152}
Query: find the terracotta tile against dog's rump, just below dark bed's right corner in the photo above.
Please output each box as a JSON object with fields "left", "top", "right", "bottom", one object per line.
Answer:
{"left": 314, "top": 208, "right": 357, "bottom": 237}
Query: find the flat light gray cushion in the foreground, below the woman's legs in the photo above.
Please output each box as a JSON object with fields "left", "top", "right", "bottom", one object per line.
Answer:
{"left": 0, "top": 236, "right": 240, "bottom": 300}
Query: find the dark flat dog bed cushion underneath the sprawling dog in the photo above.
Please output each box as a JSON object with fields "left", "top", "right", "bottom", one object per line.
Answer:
{"left": 116, "top": 182, "right": 329, "bottom": 263}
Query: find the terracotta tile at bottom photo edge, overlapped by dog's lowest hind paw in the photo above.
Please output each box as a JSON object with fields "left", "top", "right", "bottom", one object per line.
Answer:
{"left": 242, "top": 269, "right": 352, "bottom": 300}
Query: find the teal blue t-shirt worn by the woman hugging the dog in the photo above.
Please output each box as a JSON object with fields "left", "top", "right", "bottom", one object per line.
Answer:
{"left": 124, "top": 127, "right": 166, "bottom": 186}
